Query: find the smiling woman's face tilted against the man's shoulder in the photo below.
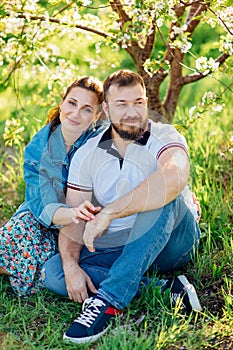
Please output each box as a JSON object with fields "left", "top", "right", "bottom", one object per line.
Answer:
{"left": 60, "top": 87, "right": 98, "bottom": 133}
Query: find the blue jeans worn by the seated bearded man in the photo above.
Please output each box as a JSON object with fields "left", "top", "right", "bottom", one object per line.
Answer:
{"left": 44, "top": 195, "right": 200, "bottom": 309}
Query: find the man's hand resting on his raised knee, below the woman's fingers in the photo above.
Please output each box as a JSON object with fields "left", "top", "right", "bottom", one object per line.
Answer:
{"left": 83, "top": 209, "right": 112, "bottom": 252}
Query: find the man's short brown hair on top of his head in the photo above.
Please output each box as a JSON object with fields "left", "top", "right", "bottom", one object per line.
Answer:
{"left": 103, "top": 69, "right": 146, "bottom": 102}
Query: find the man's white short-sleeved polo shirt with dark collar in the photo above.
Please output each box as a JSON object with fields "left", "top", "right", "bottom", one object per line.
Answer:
{"left": 67, "top": 121, "right": 191, "bottom": 245}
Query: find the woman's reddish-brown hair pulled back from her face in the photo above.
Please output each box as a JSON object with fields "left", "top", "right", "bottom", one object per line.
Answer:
{"left": 46, "top": 76, "right": 104, "bottom": 131}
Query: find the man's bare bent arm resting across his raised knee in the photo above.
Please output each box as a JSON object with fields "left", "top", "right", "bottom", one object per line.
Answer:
{"left": 83, "top": 147, "right": 190, "bottom": 251}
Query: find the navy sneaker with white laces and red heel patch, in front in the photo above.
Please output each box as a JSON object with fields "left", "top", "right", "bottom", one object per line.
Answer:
{"left": 63, "top": 297, "right": 122, "bottom": 344}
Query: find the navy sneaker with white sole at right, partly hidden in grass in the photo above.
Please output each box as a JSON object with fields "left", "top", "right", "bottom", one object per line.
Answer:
{"left": 162, "top": 275, "right": 202, "bottom": 312}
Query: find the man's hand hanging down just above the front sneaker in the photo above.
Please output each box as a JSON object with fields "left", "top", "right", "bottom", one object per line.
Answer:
{"left": 64, "top": 264, "right": 97, "bottom": 304}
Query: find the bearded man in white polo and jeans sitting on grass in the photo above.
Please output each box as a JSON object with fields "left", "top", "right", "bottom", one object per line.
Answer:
{"left": 45, "top": 70, "right": 201, "bottom": 343}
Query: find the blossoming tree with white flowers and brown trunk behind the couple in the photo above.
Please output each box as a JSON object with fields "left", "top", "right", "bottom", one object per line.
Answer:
{"left": 0, "top": 0, "right": 233, "bottom": 121}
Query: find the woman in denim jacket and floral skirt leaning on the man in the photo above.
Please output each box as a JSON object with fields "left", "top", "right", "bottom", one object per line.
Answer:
{"left": 0, "top": 76, "right": 107, "bottom": 295}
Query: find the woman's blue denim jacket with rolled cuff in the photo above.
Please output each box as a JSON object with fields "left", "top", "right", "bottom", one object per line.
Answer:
{"left": 15, "top": 122, "right": 108, "bottom": 229}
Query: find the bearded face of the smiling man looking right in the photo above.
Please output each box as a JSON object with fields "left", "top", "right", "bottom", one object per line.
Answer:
{"left": 103, "top": 84, "right": 148, "bottom": 140}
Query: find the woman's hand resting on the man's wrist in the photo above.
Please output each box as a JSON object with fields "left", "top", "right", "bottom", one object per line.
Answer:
{"left": 72, "top": 200, "right": 101, "bottom": 224}
